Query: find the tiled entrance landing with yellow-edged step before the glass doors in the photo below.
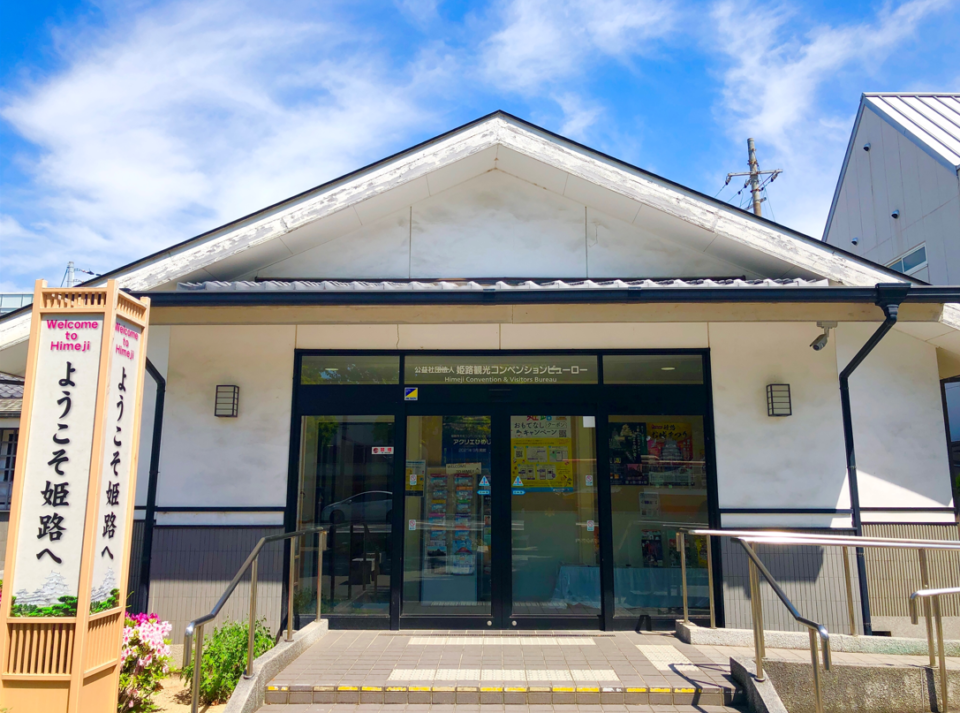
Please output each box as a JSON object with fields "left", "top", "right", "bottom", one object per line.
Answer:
{"left": 261, "top": 630, "right": 744, "bottom": 711}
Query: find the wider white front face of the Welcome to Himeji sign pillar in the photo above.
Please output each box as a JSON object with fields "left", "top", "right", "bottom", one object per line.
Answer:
{"left": 10, "top": 315, "right": 103, "bottom": 617}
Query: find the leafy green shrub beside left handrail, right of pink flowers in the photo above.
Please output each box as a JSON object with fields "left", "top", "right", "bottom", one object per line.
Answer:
{"left": 182, "top": 621, "right": 273, "bottom": 705}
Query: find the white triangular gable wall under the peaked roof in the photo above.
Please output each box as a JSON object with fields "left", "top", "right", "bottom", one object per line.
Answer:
{"left": 257, "top": 170, "right": 760, "bottom": 279}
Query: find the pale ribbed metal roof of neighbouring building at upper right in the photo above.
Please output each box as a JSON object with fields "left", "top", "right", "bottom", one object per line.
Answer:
{"left": 863, "top": 93, "right": 960, "bottom": 171}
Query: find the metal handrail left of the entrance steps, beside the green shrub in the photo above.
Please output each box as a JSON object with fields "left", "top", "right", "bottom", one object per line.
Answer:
{"left": 183, "top": 525, "right": 330, "bottom": 713}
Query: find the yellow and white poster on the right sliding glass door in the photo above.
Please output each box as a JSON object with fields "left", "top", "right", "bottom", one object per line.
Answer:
{"left": 510, "top": 416, "right": 574, "bottom": 492}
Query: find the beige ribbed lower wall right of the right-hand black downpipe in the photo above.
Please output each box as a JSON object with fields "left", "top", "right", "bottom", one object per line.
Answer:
{"left": 863, "top": 523, "right": 960, "bottom": 618}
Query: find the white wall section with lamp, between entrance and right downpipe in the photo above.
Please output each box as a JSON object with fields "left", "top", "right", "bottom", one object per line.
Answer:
{"left": 709, "top": 323, "right": 850, "bottom": 527}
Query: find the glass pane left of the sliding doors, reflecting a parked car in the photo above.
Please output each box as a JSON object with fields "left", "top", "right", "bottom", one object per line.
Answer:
{"left": 294, "top": 416, "right": 394, "bottom": 623}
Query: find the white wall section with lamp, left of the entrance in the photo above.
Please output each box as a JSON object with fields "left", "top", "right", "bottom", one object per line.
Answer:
{"left": 157, "top": 325, "right": 296, "bottom": 524}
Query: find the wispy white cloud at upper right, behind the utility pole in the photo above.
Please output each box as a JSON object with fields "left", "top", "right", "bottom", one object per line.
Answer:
{"left": 711, "top": 0, "right": 948, "bottom": 237}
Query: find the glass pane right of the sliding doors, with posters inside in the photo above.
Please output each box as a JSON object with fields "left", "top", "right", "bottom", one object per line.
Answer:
{"left": 605, "top": 416, "right": 709, "bottom": 617}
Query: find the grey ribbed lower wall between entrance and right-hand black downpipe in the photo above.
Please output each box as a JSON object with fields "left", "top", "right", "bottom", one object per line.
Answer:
{"left": 720, "top": 530, "right": 863, "bottom": 634}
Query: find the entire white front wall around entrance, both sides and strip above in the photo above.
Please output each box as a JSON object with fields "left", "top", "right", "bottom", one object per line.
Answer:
{"left": 150, "top": 322, "right": 951, "bottom": 527}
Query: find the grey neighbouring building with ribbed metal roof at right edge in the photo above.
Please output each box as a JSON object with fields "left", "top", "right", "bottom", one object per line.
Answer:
{"left": 823, "top": 93, "right": 960, "bottom": 285}
